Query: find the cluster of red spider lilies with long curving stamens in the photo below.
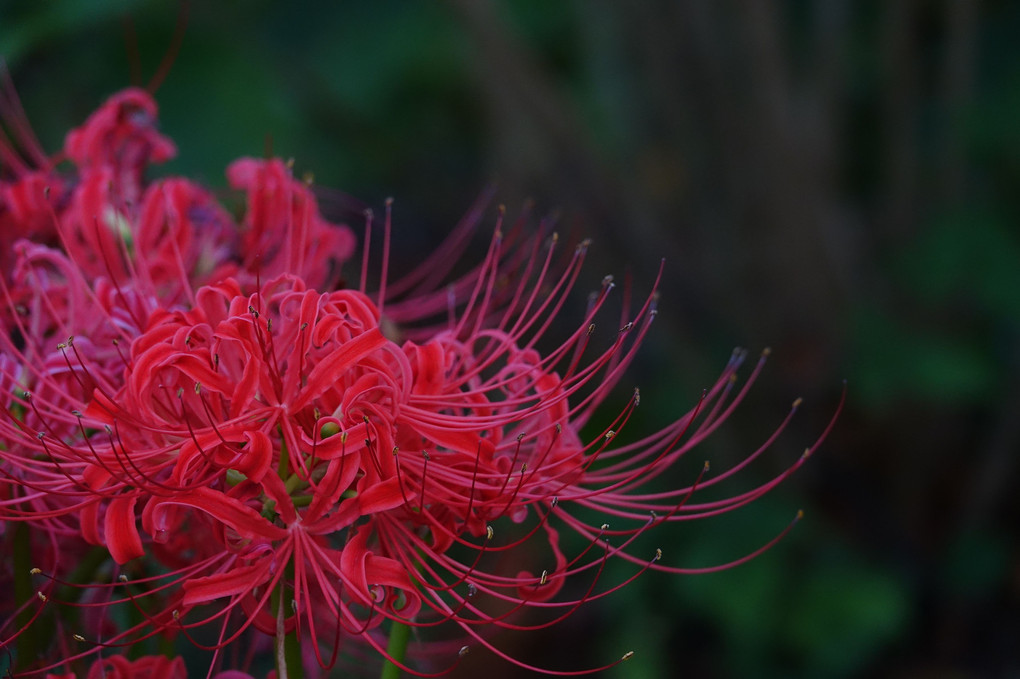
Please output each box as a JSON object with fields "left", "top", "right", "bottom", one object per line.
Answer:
{"left": 0, "top": 82, "right": 836, "bottom": 677}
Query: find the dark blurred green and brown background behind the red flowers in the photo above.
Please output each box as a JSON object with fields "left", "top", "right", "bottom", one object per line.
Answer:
{"left": 0, "top": 0, "right": 1020, "bottom": 679}
